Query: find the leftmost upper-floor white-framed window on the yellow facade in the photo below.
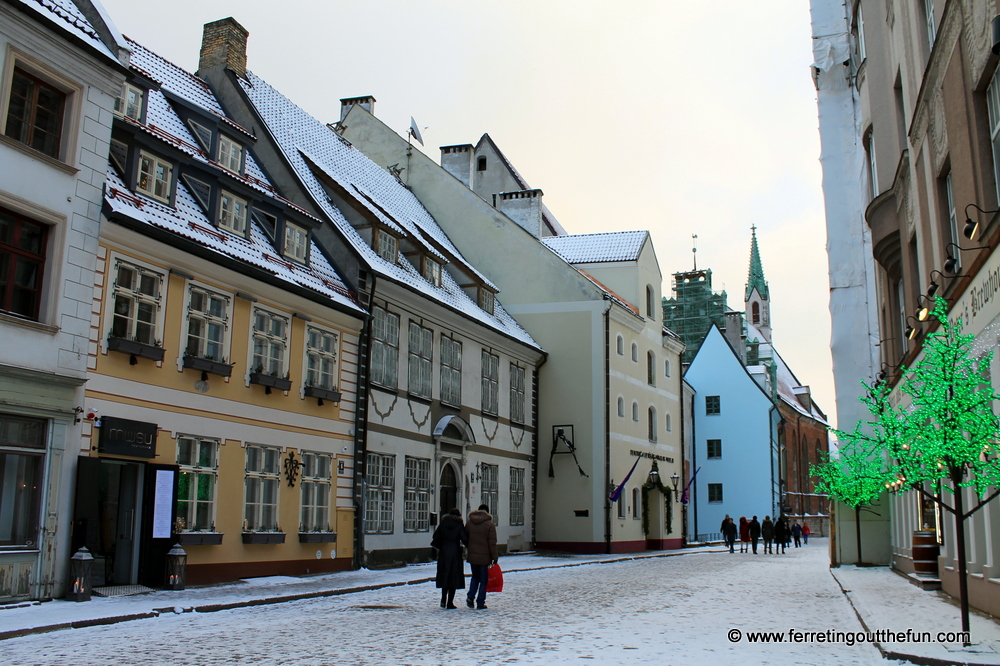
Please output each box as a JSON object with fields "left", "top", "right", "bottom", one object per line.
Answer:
{"left": 111, "top": 261, "right": 163, "bottom": 346}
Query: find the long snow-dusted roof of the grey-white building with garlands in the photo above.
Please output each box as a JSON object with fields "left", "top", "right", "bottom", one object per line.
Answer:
{"left": 240, "top": 71, "right": 540, "bottom": 348}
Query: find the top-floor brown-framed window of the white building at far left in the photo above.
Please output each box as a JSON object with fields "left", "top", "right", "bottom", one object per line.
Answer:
{"left": 4, "top": 67, "right": 66, "bottom": 159}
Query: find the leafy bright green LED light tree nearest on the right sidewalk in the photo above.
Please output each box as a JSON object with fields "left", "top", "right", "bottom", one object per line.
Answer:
{"left": 886, "top": 298, "right": 1000, "bottom": 631}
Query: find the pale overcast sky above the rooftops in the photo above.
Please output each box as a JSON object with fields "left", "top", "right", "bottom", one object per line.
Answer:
{"left": 102, "top": 0, "right": 836, "bottom": 422}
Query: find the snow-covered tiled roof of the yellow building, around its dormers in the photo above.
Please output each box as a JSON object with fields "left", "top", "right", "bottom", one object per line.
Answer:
{"left": 104, "top": 41, "right": 363, "bottom": 313}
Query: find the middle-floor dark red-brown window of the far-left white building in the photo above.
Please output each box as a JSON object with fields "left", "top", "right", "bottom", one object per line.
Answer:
{"left": 0, "top": 208, "right": 48, "bottom": 320}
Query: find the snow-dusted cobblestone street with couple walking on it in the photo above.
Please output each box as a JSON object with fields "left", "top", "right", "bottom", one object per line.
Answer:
{"left": 2, "top": 540, "right": 888, "bottom": 666}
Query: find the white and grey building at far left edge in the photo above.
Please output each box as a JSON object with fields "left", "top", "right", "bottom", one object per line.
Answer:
{"left": 0, "top": 0, "right": 128, "bottom": 602}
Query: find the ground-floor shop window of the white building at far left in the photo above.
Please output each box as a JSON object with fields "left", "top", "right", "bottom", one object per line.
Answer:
{"left": 0, "top": 414, "right": 47, "bottom": 548}
